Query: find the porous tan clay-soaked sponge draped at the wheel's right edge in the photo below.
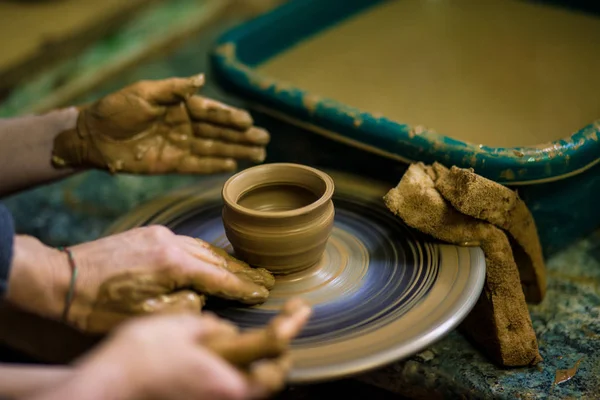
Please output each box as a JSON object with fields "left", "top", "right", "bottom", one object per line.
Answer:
{"left": 384, "top": 163, "right": 545, "bottom": 366}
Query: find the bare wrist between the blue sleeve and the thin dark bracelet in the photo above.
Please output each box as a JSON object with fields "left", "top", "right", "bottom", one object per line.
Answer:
{"left": 6, "top": 235, "right": 71, "bottom": 319}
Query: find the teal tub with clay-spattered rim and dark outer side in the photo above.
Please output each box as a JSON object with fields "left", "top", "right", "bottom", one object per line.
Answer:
{"left": 210, "top": 0, "right": 600, "bottom": 255}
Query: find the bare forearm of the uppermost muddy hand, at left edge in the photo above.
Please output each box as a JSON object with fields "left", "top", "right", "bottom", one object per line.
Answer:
{"left": 0, "top": 107, "right": 79, "bottom": 197}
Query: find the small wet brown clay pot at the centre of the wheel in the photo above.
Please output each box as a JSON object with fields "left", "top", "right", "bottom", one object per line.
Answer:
{"left": 222, "top": 163, "right": 335, "bottom": 274}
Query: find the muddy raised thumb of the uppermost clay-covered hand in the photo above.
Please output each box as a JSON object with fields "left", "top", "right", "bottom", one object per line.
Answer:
{"left": 132, "top": 74, "right": 204, "bottom": 104}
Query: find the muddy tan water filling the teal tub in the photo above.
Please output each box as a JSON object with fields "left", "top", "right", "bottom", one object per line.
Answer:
{"left": 259, "top": 0, "right": 600, "bottom": 147}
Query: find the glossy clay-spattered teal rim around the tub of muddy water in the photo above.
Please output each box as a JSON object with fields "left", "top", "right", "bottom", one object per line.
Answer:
{"left": 213, "top": 0, "right": 600, "bottom": 185}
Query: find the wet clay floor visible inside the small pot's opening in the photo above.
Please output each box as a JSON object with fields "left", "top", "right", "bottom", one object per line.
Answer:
{"left": 238, "top": 185, "right": 319, "bottom": 211}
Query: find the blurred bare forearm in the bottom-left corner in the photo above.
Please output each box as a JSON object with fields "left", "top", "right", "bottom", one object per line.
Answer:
{"left": 0, "top": 364, "right": 73, "bottom": 399}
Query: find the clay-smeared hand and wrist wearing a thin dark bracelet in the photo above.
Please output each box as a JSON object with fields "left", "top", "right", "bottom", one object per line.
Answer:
{"left": 7, "top": 226, "right": 274, "bottom": 333}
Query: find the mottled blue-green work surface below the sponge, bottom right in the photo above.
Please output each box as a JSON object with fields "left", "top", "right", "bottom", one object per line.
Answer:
{"left": 362, "top": 233, "right": 600, "bottom": 399}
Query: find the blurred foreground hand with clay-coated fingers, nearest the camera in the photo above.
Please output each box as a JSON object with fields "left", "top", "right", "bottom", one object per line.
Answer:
{"left": 32, "top": 301, "right": 310, "bottom": 400}
